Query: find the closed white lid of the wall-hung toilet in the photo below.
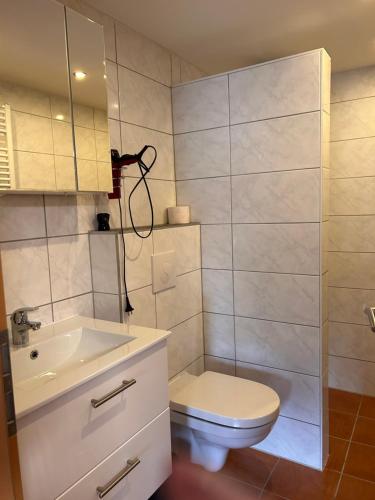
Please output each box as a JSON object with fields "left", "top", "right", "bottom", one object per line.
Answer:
{"left": 170, "top": 371, "right": 280, "bottom": 428}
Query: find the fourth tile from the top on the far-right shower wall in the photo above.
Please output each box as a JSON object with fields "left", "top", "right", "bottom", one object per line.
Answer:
{"left": 330, "top": 177, "right": 375, "bottom": 215}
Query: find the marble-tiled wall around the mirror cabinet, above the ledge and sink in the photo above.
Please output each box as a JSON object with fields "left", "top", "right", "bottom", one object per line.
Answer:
{"left": 0, "top": 0, "right": 206, "bottom": 332}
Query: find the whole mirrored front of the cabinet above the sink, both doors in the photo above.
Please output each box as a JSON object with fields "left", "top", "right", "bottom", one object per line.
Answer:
{"left": 0, "top": 0, "right": 112, "bottom": 193}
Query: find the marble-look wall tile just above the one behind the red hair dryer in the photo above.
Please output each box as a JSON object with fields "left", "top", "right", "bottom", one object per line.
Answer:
{"left": 119, "top": 66, "right": 172, "bottom": 134}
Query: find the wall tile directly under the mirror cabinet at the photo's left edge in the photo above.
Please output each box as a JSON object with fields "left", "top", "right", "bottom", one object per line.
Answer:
{"left": 0, "top": 194, "right": 46, "bottom": 241}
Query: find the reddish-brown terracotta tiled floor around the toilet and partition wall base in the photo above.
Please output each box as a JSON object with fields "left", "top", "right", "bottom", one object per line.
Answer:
{"left": 160, "top": 390, "right": 375, "bottom": 500}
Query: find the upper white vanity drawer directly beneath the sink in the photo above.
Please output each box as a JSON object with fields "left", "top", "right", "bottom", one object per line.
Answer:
{"left": 17, "top": 343, "right": 169, "bottom": 500}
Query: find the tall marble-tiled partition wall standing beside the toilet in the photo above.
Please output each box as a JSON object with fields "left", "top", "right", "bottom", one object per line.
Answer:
{"left": 172, "top": 51, "right": 330, "bottom": 468}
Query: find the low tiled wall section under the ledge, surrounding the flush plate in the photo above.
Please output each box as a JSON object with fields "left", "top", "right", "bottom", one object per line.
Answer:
{"left": 90, "top": 225, "right": 203, "bottom": 377}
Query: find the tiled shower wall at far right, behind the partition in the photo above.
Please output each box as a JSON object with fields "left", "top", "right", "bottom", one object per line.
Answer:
{"left": 329, "top": 66, "right": 375, "bottom": 396}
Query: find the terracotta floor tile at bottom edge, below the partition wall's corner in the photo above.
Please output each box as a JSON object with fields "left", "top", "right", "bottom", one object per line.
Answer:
{"left": 265, "top": 459, "right": 340, "bottom": 500}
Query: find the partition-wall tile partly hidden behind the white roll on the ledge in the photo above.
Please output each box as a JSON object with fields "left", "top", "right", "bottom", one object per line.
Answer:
{"left": 176, "top": 177, "right": 231, "bottom": 224}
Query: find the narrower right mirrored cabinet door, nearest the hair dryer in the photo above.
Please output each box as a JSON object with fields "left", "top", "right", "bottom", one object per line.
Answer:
{"left": 66, "top": 8, "right": 112, "bottom": 192}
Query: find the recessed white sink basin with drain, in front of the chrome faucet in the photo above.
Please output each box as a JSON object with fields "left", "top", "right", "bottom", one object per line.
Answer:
{"left": 12, "top": 327, "right": 135, "bottom": 389}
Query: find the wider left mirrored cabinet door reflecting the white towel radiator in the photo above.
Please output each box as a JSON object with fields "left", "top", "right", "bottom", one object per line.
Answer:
{"left": 0, "top": 0, "right": 76, "bottom": 193}
